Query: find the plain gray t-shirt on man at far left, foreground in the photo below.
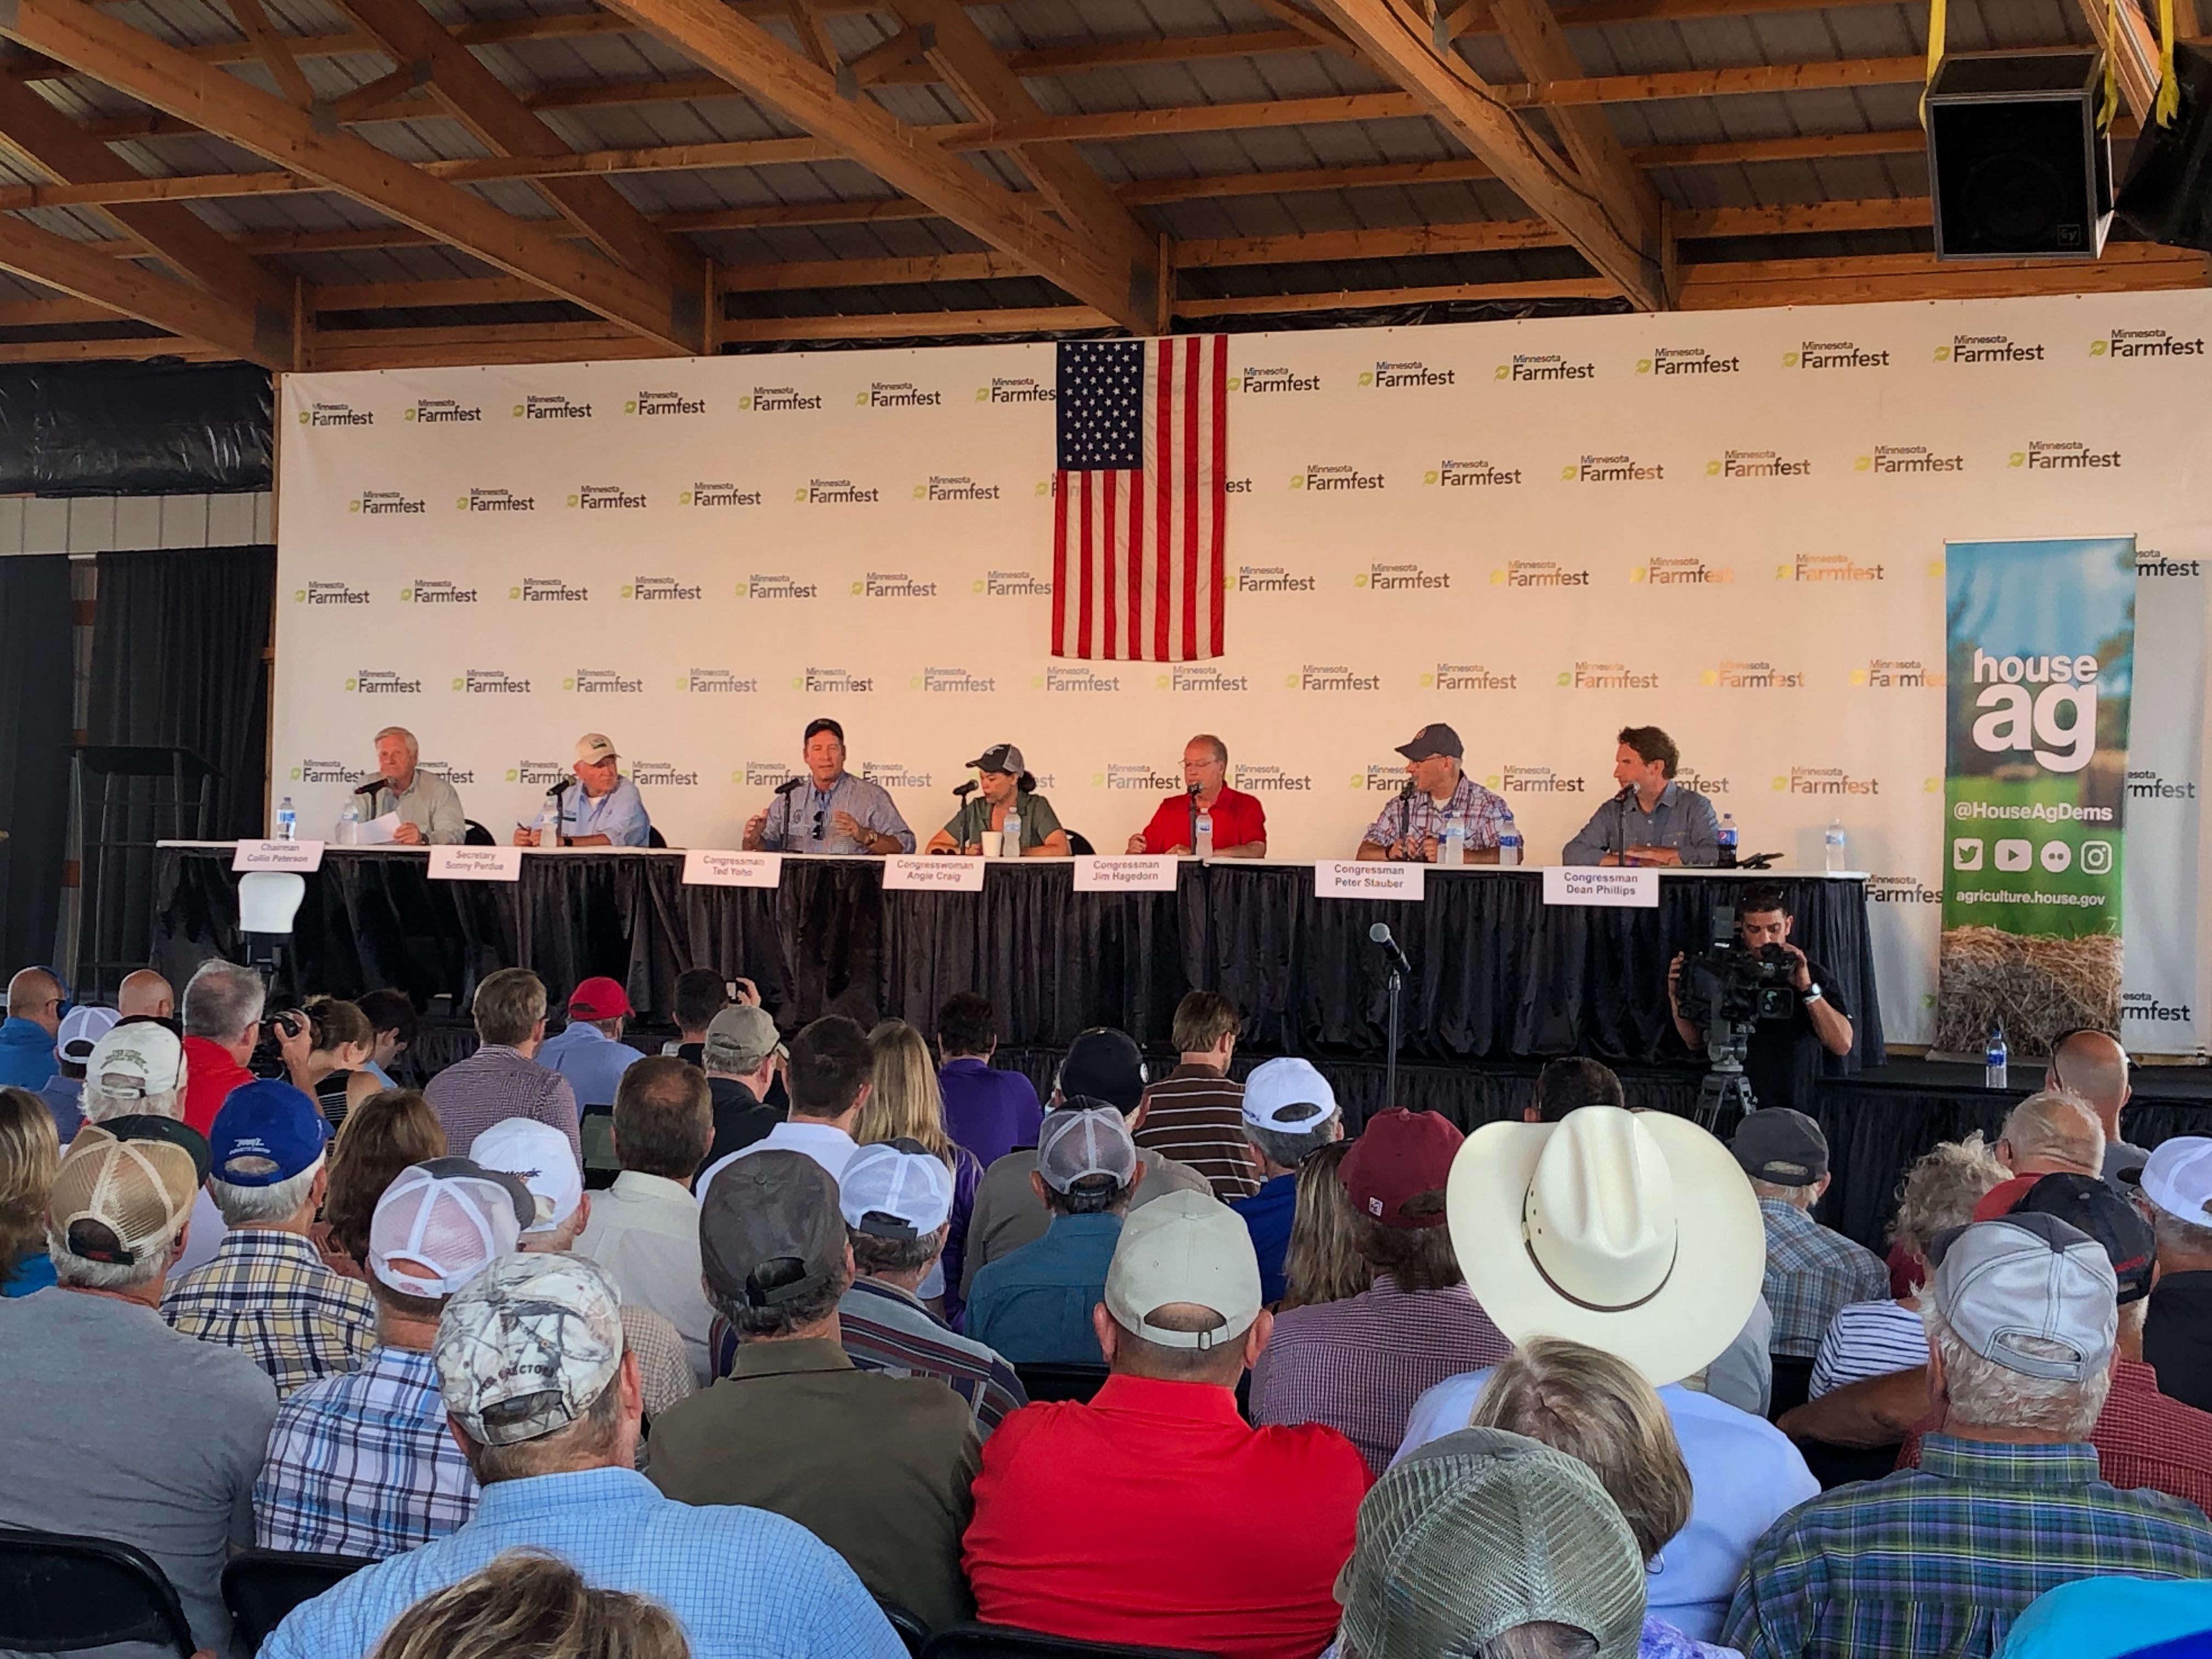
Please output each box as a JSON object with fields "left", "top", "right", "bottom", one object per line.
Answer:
{"left": 0, "top": 1290, "right": 276, "bottom": 1659}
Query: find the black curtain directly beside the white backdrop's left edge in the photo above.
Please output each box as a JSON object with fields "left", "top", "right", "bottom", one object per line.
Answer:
{"left": 82, "top": 546, "right": 276, "bottom": 982}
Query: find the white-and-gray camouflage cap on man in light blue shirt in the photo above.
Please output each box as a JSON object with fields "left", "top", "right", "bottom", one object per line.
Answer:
{"left": 431, "top": 1254, "right": 622, "bottom": 1447}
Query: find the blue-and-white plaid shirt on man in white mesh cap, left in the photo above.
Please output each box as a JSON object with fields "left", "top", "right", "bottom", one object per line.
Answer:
{"left": 255, "top": 1347, "right": 478, "bottom": 1560}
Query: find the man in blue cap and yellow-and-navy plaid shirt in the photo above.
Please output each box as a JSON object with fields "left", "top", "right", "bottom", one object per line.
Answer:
{"left": 161, "top": 1082, "right": 376, "bottom": 1400}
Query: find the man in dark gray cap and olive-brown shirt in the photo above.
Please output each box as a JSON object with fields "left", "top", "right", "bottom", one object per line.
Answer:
{"left": 648, "top": 1150, "right": 978, "bottom": 1628}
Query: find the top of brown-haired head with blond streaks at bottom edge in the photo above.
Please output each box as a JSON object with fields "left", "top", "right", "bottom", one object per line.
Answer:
{"left": 376, "top": 1550, "right": 690, "bottom": 1659}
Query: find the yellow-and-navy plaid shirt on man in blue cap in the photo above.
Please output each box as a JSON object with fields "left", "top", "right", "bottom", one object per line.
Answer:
{"left": 161, "top": 1228, "right": 376, "bottom": 1400}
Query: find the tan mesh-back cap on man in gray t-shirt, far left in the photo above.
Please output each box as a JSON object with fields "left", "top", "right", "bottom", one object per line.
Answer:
{"left": 47, "top": 1115, "right": 208, "bottom": 1267}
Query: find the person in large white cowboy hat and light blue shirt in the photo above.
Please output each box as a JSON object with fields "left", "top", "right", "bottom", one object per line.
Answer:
{"left": 1400, "top": 1106, "right": 1820, "bottom": 1641}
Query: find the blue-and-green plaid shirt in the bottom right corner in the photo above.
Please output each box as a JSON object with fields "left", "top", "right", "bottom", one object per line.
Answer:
{"left": 1721, "top": 1434, "right": 2212, "bottom": 1659}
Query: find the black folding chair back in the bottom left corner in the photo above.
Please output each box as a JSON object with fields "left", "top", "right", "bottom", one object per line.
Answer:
{"left": 0, "top": 1526, "right": 197, "bottom": 1659}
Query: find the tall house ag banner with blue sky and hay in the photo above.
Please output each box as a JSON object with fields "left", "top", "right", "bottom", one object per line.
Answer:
{"left": 1936, "top": 535, "right": 2135, "bottom": 1053}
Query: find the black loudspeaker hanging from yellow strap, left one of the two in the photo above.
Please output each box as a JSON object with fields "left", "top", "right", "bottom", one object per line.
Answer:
{"left": 1927, "top": 51, "right": 2113, "bottom": 259}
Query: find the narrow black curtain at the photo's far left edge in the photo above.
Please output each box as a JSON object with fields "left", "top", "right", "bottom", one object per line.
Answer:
{"left": 0, "top": 555, "right": 73, "bottom": 978}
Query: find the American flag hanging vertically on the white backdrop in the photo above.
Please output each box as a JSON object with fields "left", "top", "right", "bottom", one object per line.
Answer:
{"left": 1053, "top": 334, "right": 1230, "bottom": 662}
